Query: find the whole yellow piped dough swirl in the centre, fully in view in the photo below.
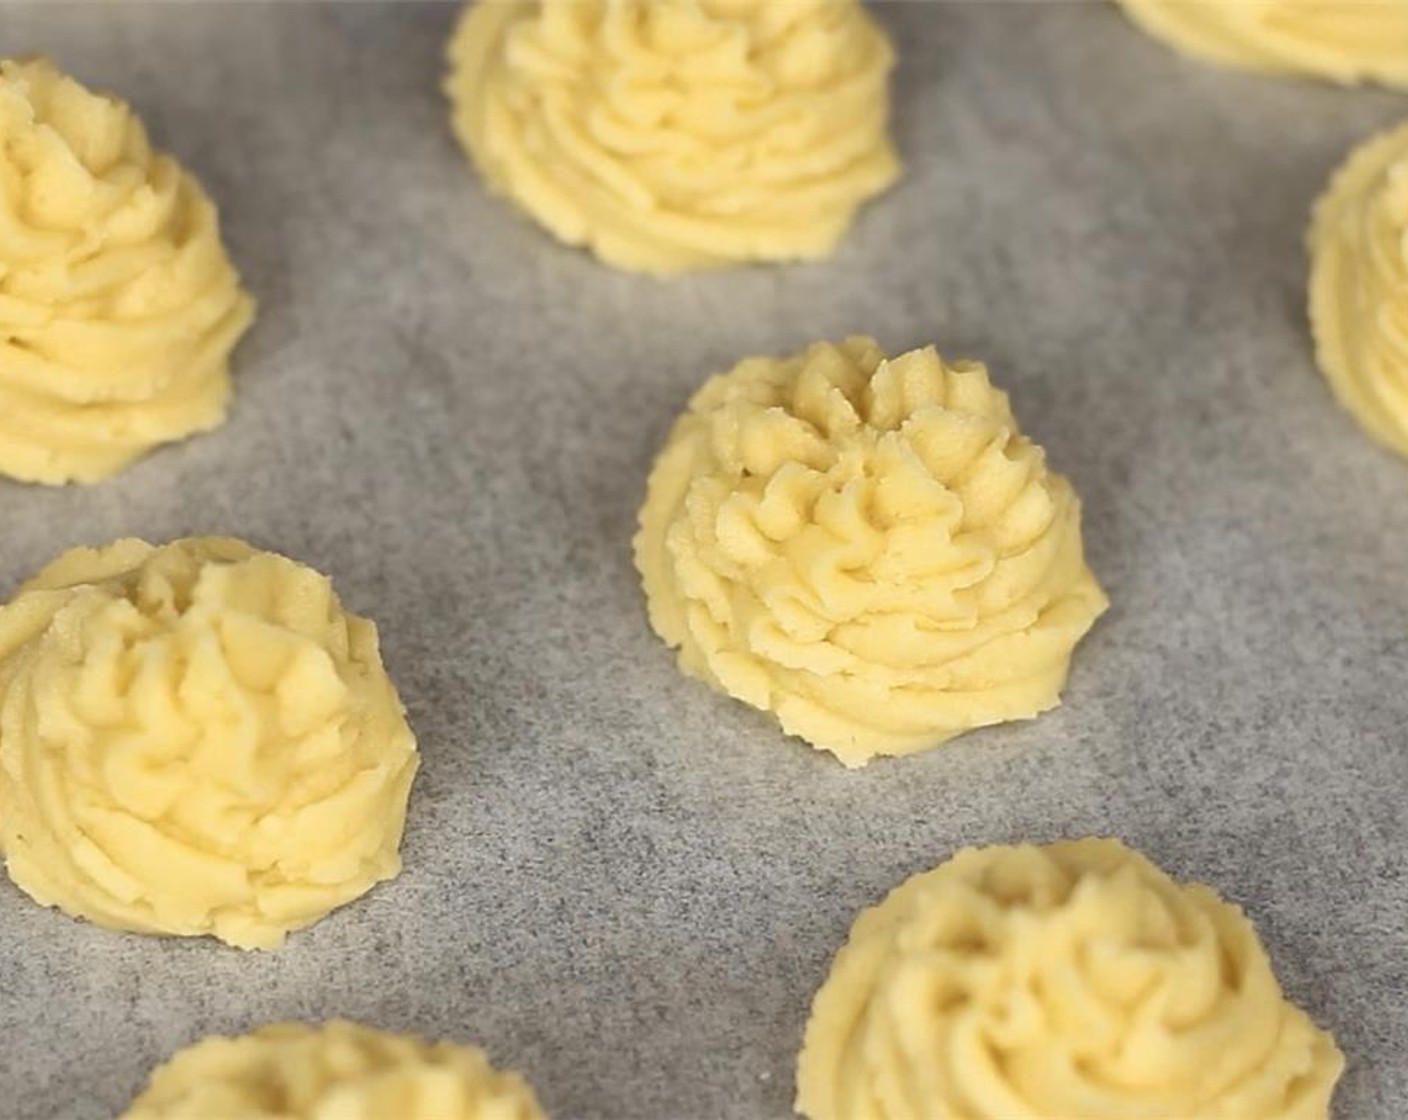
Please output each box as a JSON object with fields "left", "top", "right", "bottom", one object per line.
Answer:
{"left": 635, "top": 338, "right": 1107, "bottom": 766}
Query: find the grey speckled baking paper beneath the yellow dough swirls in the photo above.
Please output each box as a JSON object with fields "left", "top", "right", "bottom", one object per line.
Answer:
{"left": 0, "top": 3, "right": 1408, "bottom": 1120}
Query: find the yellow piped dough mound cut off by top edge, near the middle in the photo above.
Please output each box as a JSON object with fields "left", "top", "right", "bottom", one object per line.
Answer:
{"left": 445, "top": 0, "right": 900, "bottom": 273}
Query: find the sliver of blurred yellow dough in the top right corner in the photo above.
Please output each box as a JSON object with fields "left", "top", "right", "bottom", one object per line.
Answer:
{"left": 1119, "top": 0, "right": 1408, "bottom": 86}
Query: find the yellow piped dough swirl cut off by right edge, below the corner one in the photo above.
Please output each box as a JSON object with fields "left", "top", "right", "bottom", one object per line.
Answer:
{"left": 1309, "top": 124, "right": 1408, "bottom": 455}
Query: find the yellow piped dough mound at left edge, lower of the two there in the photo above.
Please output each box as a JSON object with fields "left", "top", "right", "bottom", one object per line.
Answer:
{"left": 0, "top": 538, "right": 417, "bottom": 948}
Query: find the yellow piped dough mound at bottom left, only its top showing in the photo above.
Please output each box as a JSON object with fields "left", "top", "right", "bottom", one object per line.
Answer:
{"left": 120, "top": 1020, "right": 542, "bottom": 1120}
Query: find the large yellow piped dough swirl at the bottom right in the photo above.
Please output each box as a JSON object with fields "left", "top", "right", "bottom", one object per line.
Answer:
{"left": 797, "top": 840, "right": 1343, "bottom": 1120}
